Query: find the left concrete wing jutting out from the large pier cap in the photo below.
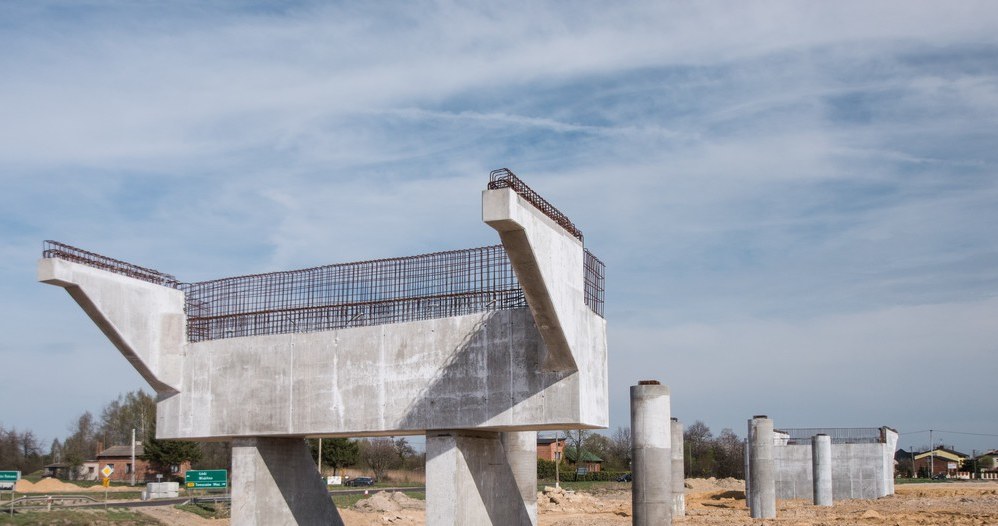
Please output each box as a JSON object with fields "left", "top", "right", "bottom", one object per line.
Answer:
{"left": 38, "top": 258, "right": 187, "bottom": 399}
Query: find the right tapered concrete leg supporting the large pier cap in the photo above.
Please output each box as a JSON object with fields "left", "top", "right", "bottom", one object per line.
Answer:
{"left": 426, "top": 430, "right": 536, "bottom": 526}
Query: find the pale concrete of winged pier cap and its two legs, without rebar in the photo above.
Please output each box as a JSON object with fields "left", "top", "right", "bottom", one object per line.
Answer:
{"left": 38, "top": 183, "right": 608, "bottom": 525}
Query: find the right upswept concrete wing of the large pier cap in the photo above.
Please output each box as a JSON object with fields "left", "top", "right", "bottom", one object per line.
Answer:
{"left": 482, "top": 188, "right": 590, "bottom": 371}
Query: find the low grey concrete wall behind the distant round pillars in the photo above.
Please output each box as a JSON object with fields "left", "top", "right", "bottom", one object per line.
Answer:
{"left": 773, "top": 430, "right": 897, "bottom": 500}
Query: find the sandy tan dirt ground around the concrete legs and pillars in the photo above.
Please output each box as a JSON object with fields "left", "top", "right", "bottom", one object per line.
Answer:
{"left": 129, "top": 479, "right": 998, "bottom": 526}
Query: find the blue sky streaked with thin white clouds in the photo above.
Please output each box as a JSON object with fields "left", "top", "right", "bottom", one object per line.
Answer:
{"left": 0, "top": 1, "right": 998, "bottom": 451}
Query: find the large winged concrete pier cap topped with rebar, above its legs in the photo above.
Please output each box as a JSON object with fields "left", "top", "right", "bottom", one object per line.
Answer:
{"left": 38, "top": 169, "right": 608, "bottom": 440}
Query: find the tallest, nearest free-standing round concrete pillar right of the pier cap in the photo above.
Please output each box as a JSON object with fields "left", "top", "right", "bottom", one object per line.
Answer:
{"left": 631, "top": 380, "right": 672, "bottom": 526}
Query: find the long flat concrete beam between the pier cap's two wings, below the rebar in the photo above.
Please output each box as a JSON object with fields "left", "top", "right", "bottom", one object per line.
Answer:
{"left": 157, "top": 309, "right": 607, "bottom": 438}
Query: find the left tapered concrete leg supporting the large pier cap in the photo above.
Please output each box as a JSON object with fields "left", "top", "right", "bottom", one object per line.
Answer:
{"left": 232, "top": 438, "right": 343, "bottom": 526}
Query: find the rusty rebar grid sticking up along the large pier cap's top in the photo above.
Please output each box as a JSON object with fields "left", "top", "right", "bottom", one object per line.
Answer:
{"left": 42, "top": 168, "right": 606, "bottom": 342}
